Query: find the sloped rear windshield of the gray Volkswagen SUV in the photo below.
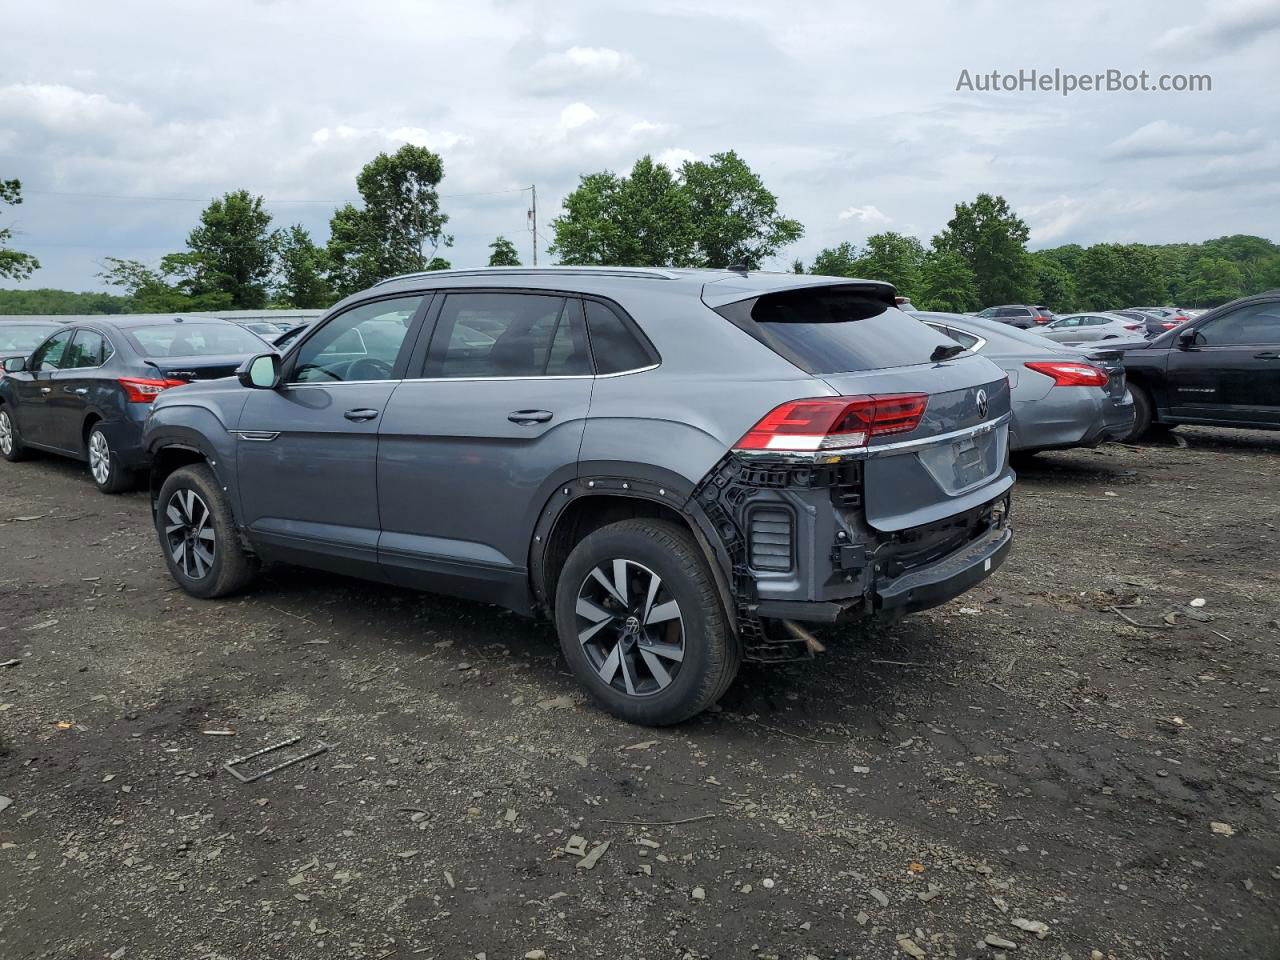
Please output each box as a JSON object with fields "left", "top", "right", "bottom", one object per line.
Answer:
{"left": 718, "top": 289, "right": 954, "bottom": 374}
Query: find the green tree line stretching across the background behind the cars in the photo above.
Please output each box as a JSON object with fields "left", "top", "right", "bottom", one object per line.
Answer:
{"left": 0, "top": 145, "right": 1280, "bottom": 312}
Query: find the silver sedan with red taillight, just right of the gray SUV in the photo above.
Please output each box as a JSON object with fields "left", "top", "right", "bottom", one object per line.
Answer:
{"left": 911, "top": 312, "right": 1134, "bottom": 453}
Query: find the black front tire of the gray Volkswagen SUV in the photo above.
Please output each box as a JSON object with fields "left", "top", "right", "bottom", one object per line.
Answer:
{"left": 155, "top": 463, "right": 257, "bottom": 598}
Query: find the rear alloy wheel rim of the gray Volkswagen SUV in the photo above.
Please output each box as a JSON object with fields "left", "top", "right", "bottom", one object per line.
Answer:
{"left": 575, "top": 558, "right": 685, "bottom": 696}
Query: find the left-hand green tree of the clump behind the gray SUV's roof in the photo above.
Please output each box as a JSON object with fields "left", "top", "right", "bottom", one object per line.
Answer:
{"left": 550, "top": 155, "right": 696, "bottom": 266}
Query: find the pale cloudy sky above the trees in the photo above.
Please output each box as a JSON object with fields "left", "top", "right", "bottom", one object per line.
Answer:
{"left": 0, "top": 0, "right": 1280, "bottom": 289}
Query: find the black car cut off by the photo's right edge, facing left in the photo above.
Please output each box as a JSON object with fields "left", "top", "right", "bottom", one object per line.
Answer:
{"left": 1108, "top": 291, "right": 1280, "bottom": 440}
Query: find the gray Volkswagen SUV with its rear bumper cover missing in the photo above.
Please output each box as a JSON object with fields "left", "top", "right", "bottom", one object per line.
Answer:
{"left": 145, "top": 268, "right": 1012, "bottom": 724}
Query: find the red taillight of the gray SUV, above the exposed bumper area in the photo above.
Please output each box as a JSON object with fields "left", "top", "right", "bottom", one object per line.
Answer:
{"left": 735, "top": 393, "right": 929, "bottom": 452}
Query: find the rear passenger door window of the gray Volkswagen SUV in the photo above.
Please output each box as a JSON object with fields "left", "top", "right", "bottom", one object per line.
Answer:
{"left": 424, "top": 293, "right": 591, "bottom": 378}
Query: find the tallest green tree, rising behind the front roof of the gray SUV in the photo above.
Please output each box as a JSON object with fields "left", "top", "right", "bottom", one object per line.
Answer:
{"left": 328, "top": 143, "right": 453, "bottom": 296}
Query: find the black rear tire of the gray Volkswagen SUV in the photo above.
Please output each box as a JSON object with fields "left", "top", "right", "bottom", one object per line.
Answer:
{"left": 556, "top": 520, "right": 741, "bottom": 727}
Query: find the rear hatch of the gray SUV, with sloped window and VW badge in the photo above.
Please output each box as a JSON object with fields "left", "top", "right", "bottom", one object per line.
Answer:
{"left": 704, "top": 283, "right": 1012, "bottom": 532}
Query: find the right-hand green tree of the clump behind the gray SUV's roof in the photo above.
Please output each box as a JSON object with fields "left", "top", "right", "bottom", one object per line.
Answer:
{"left": 680, "top": 150, "right": 804, "bottom": 270}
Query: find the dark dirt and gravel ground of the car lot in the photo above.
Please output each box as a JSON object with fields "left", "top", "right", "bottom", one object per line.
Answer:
{"left": 0, "top": 430, "right": 1280, "bottom": 960}
